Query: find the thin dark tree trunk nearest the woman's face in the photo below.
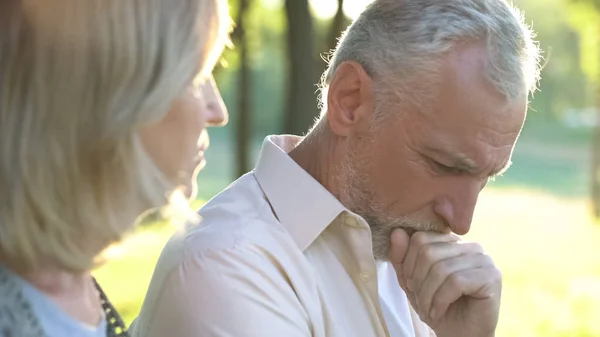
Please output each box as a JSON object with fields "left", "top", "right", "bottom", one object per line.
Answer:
{"left": 234, "top": 0, "right": 252, "bottom": 177}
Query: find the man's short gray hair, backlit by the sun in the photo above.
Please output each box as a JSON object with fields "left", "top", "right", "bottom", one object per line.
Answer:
{"left": 321, "top": 0, "right": 540, "bottom": 111}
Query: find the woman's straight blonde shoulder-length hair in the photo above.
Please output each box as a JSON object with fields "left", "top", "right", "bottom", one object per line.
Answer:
{"left": 0, "top": 0, "right": 230, "bottom": 271}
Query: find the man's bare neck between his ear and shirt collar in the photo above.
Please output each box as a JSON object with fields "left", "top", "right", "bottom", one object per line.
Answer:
{"left": 289, "top": 127, "right": 341, "bottom": 199}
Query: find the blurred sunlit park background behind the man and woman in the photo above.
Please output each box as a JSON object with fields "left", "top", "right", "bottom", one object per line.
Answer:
{"left": 95, "top": 0, "right": 600, "bottom": 337}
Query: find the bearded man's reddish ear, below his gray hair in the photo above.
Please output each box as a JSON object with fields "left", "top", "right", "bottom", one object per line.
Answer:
{"left": 327, "top": 61, "right": 375, "bottom": 137}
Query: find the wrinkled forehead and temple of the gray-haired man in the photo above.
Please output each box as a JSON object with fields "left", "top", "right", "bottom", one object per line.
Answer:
{"left": 412, "top": 45, "right": 527, "bottom": 171}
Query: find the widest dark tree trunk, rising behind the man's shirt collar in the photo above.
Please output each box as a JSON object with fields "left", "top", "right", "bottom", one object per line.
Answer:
{"left": 284, "top": 0, "right": 317, "bottom": 135}
